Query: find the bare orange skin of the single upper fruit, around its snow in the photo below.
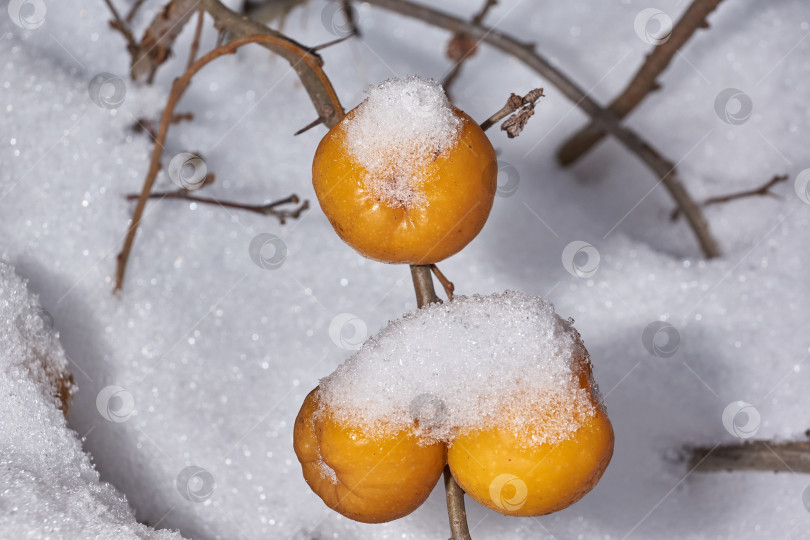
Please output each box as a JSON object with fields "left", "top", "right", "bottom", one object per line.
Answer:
{"left": 312, "top": 109, "right": 498, "bottom": 264}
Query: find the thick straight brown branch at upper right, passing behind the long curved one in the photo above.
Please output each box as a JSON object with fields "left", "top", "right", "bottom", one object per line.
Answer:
{"left": 557, "top": 0, "right": 722, "bottom": 165}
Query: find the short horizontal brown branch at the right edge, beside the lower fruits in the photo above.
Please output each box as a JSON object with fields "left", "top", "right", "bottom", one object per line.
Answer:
{"left": 689, "top": 441, "right": 810, "bottom": 474}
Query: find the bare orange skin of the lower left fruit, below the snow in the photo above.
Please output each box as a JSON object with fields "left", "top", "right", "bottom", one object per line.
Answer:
{"left": 293, "top": 388, "right": 446, "bottom": 523}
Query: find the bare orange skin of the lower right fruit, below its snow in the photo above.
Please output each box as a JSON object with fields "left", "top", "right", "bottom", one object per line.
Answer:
{"left": 447, "top": 354, "right": 613, "bottom": 516}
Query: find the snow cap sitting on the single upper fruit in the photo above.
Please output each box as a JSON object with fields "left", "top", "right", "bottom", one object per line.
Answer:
{"left": 342, "top": 76, "right": 463, "bottom": 209}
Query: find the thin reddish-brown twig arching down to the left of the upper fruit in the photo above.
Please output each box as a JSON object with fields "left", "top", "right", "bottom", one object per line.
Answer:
{"left": 114, "top": 31, "right": 343, "bottom": 291}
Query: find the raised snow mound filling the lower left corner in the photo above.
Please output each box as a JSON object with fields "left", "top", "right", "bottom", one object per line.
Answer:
{"left": 0, "top": 264, "right": 180, "bottom": 540}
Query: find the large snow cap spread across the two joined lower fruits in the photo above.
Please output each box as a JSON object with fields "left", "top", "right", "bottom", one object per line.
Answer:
{"left": 320, "top": 292, "right": 595, "bottom": 445}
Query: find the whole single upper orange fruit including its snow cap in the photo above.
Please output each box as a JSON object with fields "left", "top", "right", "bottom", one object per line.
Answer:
{"left": 312, "top": 79, "right": 497, "bottom": 264}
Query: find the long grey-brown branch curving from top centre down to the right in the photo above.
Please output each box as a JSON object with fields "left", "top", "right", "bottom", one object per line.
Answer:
{"left": 367, "top": 0, "right": 720, "bottom": 258}
